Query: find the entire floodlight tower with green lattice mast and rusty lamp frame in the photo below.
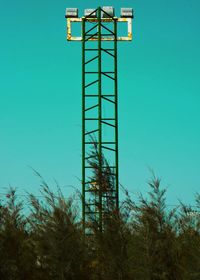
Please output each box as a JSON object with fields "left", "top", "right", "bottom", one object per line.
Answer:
{"left": 66, "top": 7, "right": 133, "bottom": 231}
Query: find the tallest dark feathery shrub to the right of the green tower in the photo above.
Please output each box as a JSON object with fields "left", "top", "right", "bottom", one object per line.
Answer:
{"left": 126, "top": 176, "right": 181, "bottom": 280}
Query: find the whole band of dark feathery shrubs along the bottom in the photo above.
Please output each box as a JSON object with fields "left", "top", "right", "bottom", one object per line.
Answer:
{"left": 0, "top": 165, "right": 200, "bottom": 280}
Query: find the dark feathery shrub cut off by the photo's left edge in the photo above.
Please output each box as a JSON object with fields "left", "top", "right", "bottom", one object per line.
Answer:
{"left": 0, "top": 188, "right": 37, "bottom": 280}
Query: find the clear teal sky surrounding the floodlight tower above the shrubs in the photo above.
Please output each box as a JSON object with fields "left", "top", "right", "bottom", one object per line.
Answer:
{"left": 0, "top": 0, "right": 200, "bottom": 204}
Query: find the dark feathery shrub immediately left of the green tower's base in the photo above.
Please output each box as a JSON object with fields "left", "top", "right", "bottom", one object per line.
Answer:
{"left": 29, "top": 178, "right": 84, "bottom": 280}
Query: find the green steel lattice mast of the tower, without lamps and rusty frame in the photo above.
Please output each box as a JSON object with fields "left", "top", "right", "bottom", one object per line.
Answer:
{"left": 82, "top": 7, "right": 119, "bottom": 231}
